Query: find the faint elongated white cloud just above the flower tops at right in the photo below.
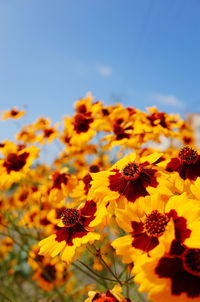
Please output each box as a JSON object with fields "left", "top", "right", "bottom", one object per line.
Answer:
{"left": 152, "top": 93, "right": 185, "bottom": 108}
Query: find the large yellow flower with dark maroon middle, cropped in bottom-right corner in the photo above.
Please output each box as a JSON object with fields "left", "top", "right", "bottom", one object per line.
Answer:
{"left": 133, "top": 238, "right": 200, "bottom": 302}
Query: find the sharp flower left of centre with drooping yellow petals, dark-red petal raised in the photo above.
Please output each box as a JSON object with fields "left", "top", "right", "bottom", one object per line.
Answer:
{"left": 39, "top": 200, "right": 106, "bottom": 263}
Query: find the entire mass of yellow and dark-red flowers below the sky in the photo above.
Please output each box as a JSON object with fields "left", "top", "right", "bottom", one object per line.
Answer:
{"left": 0, "top": 95, "right": 200, "bottom": 302}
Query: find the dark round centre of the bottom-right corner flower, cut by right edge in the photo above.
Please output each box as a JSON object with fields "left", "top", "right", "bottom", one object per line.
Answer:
{"left": 183, "top": 249, "right": 200, "bottom": 276}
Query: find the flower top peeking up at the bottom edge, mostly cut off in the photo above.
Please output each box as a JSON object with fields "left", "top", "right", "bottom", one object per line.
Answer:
{"left": 85, "top": 285, "right": 131, "bottom": 302}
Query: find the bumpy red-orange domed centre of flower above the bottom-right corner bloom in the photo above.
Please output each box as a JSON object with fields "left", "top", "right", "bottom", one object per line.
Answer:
{"left": 144, "top": 210, "right": 169, "bottom": 237}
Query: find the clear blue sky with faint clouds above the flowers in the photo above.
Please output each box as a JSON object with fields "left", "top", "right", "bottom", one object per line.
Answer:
{"left": 0, "top": 0, "right": 200, "bottom": 139}
